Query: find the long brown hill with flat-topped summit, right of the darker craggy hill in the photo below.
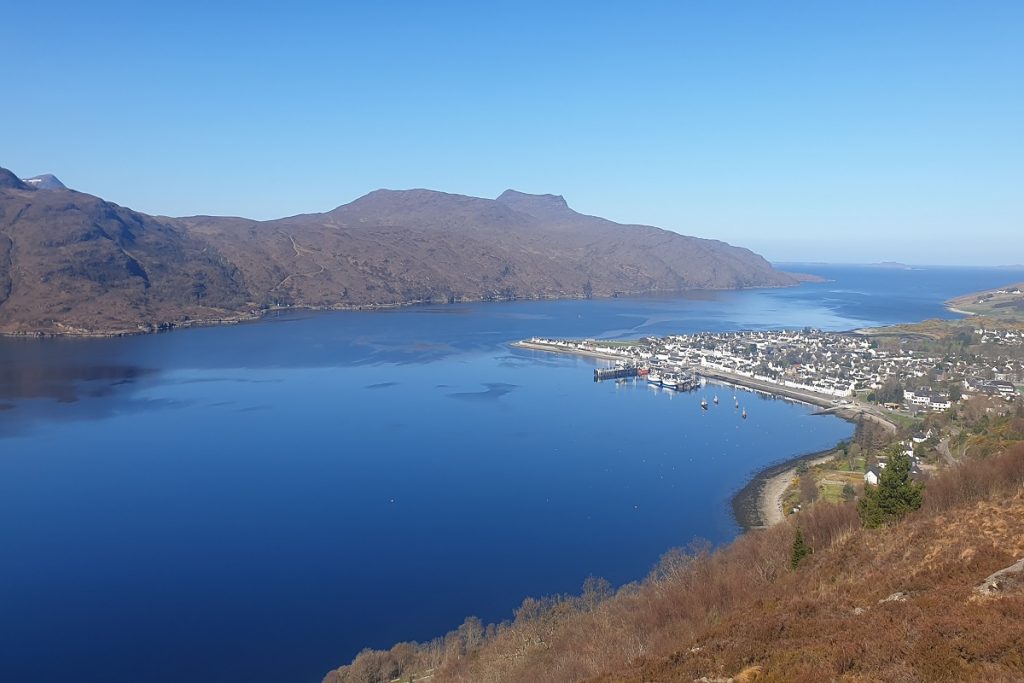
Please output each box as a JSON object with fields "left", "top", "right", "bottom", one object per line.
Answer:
{"left": 183, "top": 189, "right": 796, "bottom": 313}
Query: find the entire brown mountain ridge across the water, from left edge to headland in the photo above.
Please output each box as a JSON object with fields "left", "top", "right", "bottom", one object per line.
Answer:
{"left": 0, "top": 170, "right": 797, "bottom": 334}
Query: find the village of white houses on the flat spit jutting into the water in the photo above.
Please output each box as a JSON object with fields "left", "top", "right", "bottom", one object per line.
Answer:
{"left": 524, "top": 328, "right": 1024, "bottom": 414}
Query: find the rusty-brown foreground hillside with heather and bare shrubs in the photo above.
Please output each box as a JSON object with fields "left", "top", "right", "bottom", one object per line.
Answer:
{"left": 325, "top": 430, "right": 1024, "bottom": 683}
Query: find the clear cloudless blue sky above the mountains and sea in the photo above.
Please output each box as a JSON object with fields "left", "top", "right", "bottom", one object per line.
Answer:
{"left": 0, "top": 0, "right": 1024, "bottom": 264}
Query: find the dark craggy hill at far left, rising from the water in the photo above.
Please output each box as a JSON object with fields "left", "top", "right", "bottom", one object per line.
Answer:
{"left": 0, "top": 173, "right": 248, "bottom": 334}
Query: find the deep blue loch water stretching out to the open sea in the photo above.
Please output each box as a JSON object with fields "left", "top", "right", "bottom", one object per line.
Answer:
{"left": 0, "top": 266, "right": 1024, "bottom": 683}
